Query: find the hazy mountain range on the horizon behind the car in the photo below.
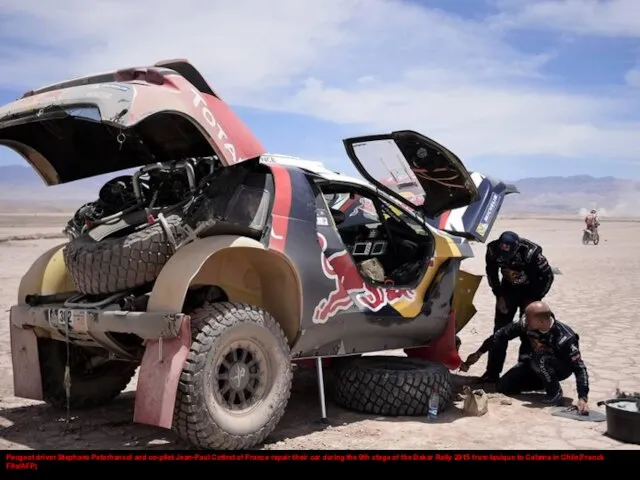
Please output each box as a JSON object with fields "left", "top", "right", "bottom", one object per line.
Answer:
{"left": 0, "top": 165, "right": 640, "bottom": 217}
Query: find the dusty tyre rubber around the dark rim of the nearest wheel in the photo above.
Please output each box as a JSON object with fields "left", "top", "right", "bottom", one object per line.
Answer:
{"left": 173, "top": 302, "right": 293, "bottom": 450}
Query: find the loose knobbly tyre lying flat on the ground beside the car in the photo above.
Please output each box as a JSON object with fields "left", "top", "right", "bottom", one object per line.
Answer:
{"left": 333, "top": 356, "right": 453, "bottom": 417}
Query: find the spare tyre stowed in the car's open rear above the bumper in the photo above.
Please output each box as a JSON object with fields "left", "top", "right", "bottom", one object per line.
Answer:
{"left": 63, "top": 214, "right": 184, "bottom": 295}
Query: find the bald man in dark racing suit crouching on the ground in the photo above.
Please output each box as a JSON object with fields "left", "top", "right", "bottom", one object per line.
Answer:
{"left": 461, "top": 302, "right": 589, "bottom": 414}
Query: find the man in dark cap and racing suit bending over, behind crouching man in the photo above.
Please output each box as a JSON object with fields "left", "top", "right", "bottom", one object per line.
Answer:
{"left": 482, "top": 232, "right": 554, "bottom": 383}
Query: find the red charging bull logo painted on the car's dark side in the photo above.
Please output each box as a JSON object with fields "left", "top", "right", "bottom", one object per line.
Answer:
{"left": 312, "top": 233, "right": 416, "bottom": 323}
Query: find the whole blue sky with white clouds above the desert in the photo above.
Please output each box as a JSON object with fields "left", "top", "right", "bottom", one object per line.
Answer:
{"left": 0, "top": 0, "right": 640, "bottom": 179}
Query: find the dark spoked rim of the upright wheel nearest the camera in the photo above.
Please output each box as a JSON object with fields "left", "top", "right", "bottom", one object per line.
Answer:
{"left": 210, "top": 341, "right": 268, "bottom": 412}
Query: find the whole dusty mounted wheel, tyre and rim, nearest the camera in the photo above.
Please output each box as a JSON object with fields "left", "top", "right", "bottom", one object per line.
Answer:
{"left": 173, "top": 302, "right": 293, "bottom": 450}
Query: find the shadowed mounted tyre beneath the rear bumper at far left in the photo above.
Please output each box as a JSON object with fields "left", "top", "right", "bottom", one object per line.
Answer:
{"left": 38, "top": 339, "right": 138, "bottom": 409}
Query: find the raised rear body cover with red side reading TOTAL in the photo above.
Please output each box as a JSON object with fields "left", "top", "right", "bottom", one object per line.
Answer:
{"left": 0, "top": 60, "right": 264, "bottom": 185}
